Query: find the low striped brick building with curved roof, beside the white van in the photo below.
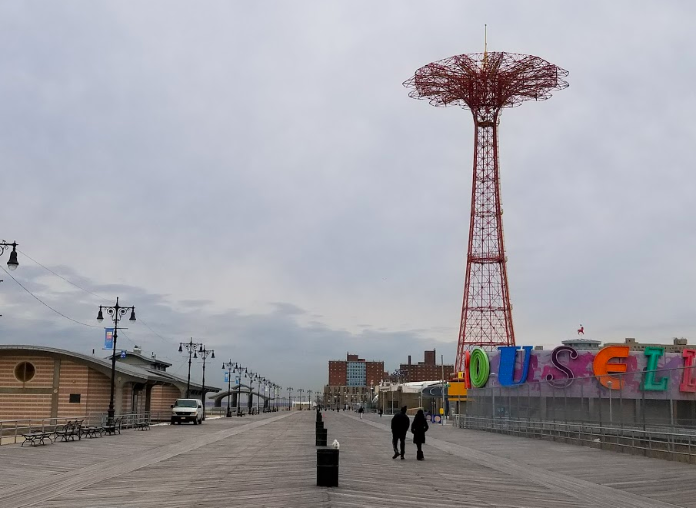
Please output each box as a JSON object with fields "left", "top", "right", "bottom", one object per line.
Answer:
{"left": 0, "top": 346, "right": 220, "bottom": 420}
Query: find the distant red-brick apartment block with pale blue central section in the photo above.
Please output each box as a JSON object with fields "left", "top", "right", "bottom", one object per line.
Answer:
{"left": 324, "top": 353, "right": 386, "bottom": 407}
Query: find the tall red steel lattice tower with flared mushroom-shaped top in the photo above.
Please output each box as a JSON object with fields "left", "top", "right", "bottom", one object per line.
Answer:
{"left": 404, "top": 52, "right": 568, "bottom": 372}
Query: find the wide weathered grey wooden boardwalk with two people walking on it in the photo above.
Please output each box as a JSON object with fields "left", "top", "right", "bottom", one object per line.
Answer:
{"left": 0, "top": 411, "right": 696, "bottom": 508}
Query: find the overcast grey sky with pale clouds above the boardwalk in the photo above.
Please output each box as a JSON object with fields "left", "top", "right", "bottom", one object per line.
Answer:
{"left": 0, "top": 0, "right": 696, "bottom": 389}
